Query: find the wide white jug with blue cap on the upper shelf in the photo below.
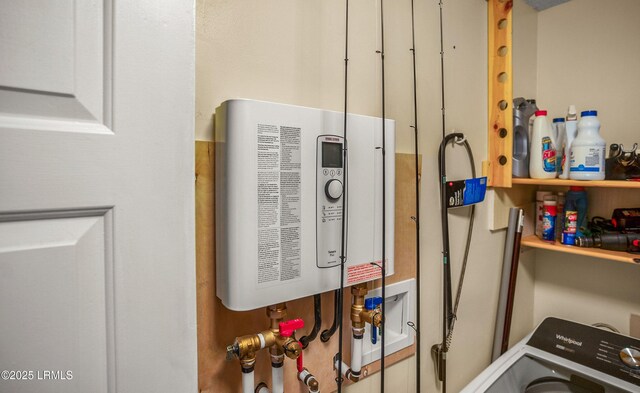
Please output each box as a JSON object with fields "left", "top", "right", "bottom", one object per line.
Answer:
{"left": 569, "top": 110, "right": 607, "bottom": 180}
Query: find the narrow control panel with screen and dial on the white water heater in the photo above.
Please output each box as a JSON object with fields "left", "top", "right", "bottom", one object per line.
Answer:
{"left": 316, "top": 135, "right": 344, "bottom": 268}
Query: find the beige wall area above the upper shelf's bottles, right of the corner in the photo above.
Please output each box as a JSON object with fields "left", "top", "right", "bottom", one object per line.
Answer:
{"left": 538, "top": 0, "right": 640, "bottom": 147}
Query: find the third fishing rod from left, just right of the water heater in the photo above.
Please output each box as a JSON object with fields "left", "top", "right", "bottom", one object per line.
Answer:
{"left": 410, "top": 0, "right": 421, "bottom": 392}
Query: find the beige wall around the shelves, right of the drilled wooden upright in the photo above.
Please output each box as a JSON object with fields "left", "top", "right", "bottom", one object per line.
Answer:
{"left": 514, "top": 0, "right": 640, "bottom": 333}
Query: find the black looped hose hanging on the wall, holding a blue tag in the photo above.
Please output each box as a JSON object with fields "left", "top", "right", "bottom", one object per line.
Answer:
{"left": 431, "top": 132, "right": 476, "bottom": 393}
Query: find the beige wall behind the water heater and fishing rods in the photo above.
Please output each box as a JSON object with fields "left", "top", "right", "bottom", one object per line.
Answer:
{"left": 196, "top": 0, "right": 504, "bottom": 393}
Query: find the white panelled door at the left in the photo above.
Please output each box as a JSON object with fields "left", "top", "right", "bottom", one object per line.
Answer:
{"left": 0, "top": 0, "right": 197, "bottom": 393}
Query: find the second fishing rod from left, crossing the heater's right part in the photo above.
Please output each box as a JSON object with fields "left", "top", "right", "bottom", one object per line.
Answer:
{"left": 380, "top": 0, "right": 387, "bottom": 393}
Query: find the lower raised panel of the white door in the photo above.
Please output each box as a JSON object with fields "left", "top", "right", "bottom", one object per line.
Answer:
{"left": 0, "top": 207, "right": 116, "bottom": 393}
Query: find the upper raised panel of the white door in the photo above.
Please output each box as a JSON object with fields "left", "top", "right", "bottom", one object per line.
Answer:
{"left": 0, "top": 0, "right": 114, "bottom": 133}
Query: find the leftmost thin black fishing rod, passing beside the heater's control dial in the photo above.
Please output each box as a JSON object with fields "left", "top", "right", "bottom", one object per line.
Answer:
{"left": 336, "top": 0, "right": 349, "bottom": 393}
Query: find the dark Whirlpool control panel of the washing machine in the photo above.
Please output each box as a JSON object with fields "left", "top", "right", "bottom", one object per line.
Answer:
{"left": 527, "top": 317, "right": 640, "bottom": 386}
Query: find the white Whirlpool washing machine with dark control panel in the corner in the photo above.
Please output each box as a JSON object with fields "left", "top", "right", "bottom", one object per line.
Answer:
{"left": 462, "top": 317, "right": 640, "bottom": 393}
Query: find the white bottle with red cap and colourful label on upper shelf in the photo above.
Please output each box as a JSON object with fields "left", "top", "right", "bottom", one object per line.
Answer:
{"left": 529, "top": 110, "right": 557, "bottom": 179}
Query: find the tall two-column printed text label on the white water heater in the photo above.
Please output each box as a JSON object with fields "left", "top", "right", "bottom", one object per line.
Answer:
{"left": 257, "top": 124, "right": 301, "bottom": 284}
